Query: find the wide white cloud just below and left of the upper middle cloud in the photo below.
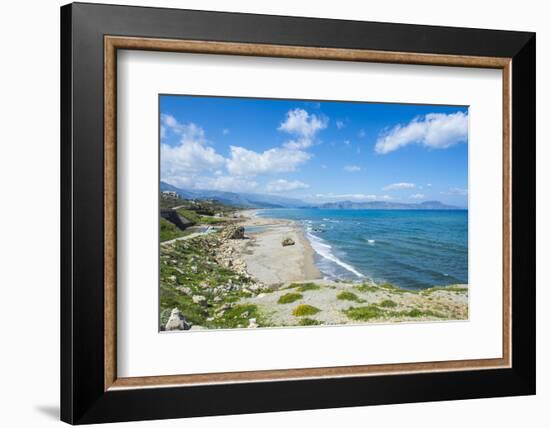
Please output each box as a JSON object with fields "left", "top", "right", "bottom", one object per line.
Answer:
{"left": 226, "top": 146, "right": 311, "bottom": 176}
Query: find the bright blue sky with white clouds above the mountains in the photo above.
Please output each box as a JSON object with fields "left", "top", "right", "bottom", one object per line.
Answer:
{"left": 160, "top": 95, "right": 468, "bottom": 206}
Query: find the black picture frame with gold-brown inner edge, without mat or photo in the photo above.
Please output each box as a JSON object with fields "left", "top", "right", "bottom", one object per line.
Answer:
{"left": 61, "top": 3, "right": 535, "bottom": 424}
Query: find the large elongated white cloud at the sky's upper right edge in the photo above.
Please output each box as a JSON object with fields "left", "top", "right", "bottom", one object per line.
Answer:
{"left": 375, "top": 111, "right": 468, "bottom": 154}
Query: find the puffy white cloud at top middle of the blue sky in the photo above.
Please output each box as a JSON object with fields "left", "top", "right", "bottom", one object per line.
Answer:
{"left": 277, "top": 108, "right": 328, "bottom": 150}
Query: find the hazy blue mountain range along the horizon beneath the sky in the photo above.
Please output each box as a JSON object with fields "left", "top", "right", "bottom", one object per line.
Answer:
{"left": 160, "top": 181, "right": 463, "bottom": 210}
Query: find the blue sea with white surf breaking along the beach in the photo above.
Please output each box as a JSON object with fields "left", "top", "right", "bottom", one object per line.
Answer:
{"left": 258, "top": 208, "right": 468, "bottom": 289}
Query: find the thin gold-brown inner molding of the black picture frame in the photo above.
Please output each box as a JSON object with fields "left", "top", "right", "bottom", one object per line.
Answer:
{"left": 104, "top": 36, "right": 512, "bottom": 391}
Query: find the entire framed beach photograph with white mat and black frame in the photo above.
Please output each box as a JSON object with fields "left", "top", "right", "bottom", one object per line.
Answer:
{"left": 61, "top": 3, "right": 535, "bottom": 424}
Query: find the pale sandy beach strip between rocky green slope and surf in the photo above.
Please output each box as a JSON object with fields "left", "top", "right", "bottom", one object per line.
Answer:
{"left": 239, "top": 210, "right": 322, "bottom": 285}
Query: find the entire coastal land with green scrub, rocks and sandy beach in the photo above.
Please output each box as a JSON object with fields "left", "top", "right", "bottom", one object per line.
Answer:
{"left": 160, "top": 211, "right": 468, "bottom": 331}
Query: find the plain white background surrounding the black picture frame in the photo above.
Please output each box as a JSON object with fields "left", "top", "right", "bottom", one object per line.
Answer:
{"left": 0, "top": 0, "right": 550, "bottom": 428}
